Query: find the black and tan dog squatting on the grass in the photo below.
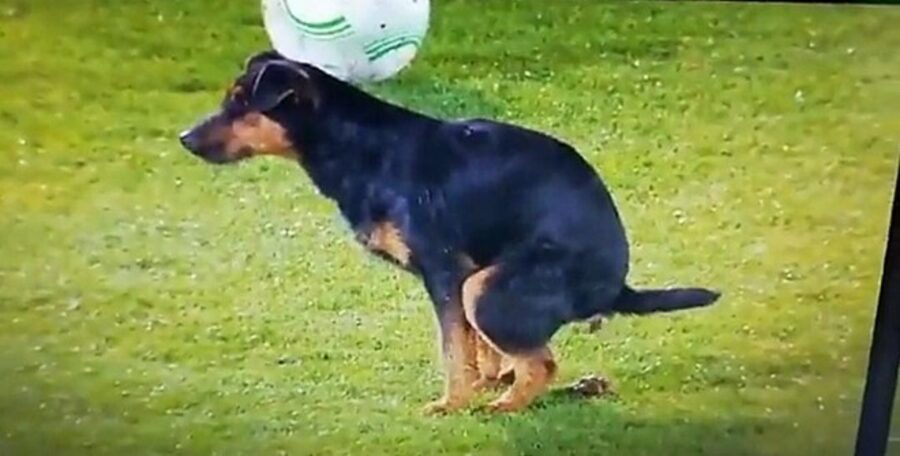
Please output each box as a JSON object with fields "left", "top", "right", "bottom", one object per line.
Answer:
{"left": 181, "top": 52, "right": 718, "bottom": 412}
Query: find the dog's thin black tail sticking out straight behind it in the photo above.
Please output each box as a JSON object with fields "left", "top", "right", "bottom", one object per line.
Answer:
{"left": 613, "top": 286, "right": 721, "bottom": 315}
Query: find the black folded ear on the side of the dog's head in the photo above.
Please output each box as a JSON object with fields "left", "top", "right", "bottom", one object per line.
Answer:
{"left": 250, "top": 59, "right": 318, "bottom": 111}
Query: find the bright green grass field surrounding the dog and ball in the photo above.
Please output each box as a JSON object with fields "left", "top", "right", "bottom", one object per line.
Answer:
{"left": 0, "top": 0, "right": 900, "bottom": 456}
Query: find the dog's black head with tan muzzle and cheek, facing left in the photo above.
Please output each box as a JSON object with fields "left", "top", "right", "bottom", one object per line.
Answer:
{"left": 179, "top": 51, "right": 318, "bottom": 163}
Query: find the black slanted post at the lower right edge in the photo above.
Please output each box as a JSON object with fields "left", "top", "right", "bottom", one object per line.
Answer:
{"left": 856, "top": 164, "right": 900, "bottom": 456}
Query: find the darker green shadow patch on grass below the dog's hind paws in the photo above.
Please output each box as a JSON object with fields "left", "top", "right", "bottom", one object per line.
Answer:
{"left": 488, "top": 390, "right": 764, "bottom": 456}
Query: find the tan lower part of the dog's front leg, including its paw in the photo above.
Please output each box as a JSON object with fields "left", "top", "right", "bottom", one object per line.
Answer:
{"left": 425, "top": 309, "right": 478, "bottom": 414}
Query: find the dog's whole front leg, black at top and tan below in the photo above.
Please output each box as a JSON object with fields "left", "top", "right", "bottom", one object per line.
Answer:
{"left": 422, "top": 262, "right": 478, "bottom": 414}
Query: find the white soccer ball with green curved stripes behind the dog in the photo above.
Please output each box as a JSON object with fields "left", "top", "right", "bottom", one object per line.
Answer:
{"left": 262, "top": 0, "right": 430, "bottom": 83}
